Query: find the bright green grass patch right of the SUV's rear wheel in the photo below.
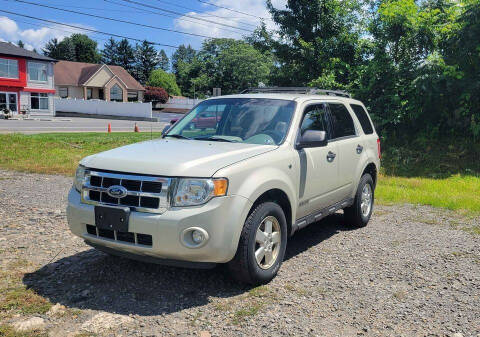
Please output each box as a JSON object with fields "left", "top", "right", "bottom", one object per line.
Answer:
{"left": 376, "top": 175, "right": 480, "bottom": 214}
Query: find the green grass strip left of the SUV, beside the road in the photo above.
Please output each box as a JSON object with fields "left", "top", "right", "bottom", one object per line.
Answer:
{"left": 0, "top": 132, "right": 161, "bottom": 175}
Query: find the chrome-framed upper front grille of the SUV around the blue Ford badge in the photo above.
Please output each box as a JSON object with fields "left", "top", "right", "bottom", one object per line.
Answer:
{"left": 82, "top": 170, "right": 171, "bottom": 213}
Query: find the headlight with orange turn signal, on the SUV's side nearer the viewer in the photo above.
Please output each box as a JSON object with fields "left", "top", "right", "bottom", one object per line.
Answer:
{"left": 172, "top": 178, "right": 228, "bottom": 206}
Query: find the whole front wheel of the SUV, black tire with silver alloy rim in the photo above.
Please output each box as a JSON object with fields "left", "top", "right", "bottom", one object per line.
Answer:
{"left": 228, "top": 202, "right": 287, "bottom": 285}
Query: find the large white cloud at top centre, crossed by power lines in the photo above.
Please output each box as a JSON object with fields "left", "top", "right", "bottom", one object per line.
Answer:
{"left": 175, "top": 0, "right": 287, "bottom": 46}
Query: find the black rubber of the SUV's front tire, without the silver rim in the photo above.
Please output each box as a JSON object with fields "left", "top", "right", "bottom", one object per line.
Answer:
{"left": 228, "top": 202, "right": 287, "bottom": 285}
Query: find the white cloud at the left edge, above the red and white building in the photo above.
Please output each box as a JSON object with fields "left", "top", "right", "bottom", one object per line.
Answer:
{"left": 0, "top": 16, "right": 95, "bottom": 50}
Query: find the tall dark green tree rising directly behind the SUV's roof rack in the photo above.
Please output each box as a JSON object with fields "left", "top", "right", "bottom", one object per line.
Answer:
{"left": 266, "top": 0, "right": 362, "bottom": 86}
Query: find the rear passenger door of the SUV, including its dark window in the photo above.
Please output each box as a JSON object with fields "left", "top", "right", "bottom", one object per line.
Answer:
{"left": 328, "top": 103, "right": 364, "bottom": 200}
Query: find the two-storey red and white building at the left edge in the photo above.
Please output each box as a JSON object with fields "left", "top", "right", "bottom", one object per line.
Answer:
{"left": 0, "top": 42, "right": 55, "bottom": 115}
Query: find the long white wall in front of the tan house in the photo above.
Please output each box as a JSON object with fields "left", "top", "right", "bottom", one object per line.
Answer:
{"left": 55, "top": 98, "right": 152, "bottom": 118}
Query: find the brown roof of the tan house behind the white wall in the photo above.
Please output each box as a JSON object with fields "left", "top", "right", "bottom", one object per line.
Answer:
{"left": 54, "top": 61, "right": 145, "bottom": 90}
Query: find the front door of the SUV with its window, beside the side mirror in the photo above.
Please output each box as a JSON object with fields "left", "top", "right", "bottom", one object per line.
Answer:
{"left": 297, "top": 103, "right": 338, "bottom": 218}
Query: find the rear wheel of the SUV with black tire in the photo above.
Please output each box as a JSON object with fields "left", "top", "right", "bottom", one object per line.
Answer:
{"left": 344, "top": 173, "right": 375, "bottom": 228}
